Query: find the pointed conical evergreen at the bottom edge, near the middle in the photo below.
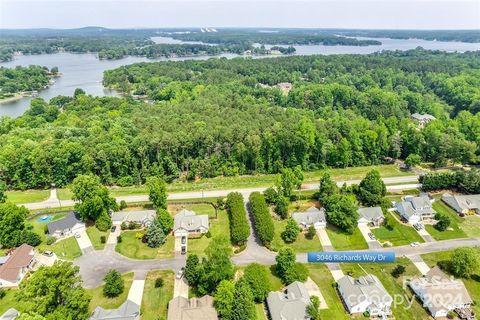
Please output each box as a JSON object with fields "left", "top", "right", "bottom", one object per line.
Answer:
{"left": 230, "top": 278, "right": 256, "bottom": 320}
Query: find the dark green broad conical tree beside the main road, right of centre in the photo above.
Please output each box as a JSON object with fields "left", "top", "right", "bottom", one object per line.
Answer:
{"left": 357, "top": 170, "right": 387, "bottom": 206}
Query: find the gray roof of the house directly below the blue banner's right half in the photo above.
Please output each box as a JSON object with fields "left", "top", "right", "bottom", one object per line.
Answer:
{"left": 337, "top": 274, "right": 393, "bottom": 306}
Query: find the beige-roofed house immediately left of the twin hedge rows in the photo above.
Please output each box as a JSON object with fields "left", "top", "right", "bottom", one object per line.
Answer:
{"left": 173, "top": 209, "right": 209, "bottom": 237}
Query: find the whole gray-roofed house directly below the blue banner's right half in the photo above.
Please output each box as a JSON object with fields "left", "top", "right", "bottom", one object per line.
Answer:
{"left": 337, "top": 274, "right": 393, "bottom": 317}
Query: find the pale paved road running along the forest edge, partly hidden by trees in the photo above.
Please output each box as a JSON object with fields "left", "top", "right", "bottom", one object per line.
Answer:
{"left": 22, "top": 176, "right": 420, "bottom": 210}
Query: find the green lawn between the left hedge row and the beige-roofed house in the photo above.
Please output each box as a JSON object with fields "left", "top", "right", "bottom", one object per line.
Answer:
{"left": 187, "top": 209, "right": 230, "bottom": 256}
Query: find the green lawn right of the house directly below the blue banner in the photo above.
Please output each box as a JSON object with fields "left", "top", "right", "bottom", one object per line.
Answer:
{"left": 341, "top": 258, "right": 429, "bottom": 320}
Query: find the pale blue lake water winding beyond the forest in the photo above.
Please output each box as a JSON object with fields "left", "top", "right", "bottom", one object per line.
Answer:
{"left": 0, "top": 37, "right": 480, "bottom": 117}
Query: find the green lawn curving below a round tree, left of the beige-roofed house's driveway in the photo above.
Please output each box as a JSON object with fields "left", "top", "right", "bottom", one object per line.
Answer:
{"left": 115, "top": 231, "right": 175, "bottom": 260}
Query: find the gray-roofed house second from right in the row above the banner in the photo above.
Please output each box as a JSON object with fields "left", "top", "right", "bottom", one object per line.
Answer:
{"left": 395, "top": 195, "right": 436, "bottom": 224}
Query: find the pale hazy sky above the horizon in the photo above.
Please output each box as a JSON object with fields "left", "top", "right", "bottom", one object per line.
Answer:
{"left": 0, "top": 0, "right": 480, "bottom": 29}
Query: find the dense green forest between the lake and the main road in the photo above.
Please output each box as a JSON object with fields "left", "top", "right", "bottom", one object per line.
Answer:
{"left": 0, "top": 50, "right": 480, "bottom": 188}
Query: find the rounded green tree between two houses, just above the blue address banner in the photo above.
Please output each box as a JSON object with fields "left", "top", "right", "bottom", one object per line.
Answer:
{"left": 324, "top": 194, "right": 358, "bottom": 234}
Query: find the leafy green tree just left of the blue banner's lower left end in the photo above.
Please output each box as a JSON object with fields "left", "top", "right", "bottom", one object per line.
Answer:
{"left": 275, "top": 247, "right": 308, "bottom": 284}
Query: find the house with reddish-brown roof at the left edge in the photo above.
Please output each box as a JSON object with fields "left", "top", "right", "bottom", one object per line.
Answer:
{"left": 0, "top": 244, "right": 35, "bottom": 288}
